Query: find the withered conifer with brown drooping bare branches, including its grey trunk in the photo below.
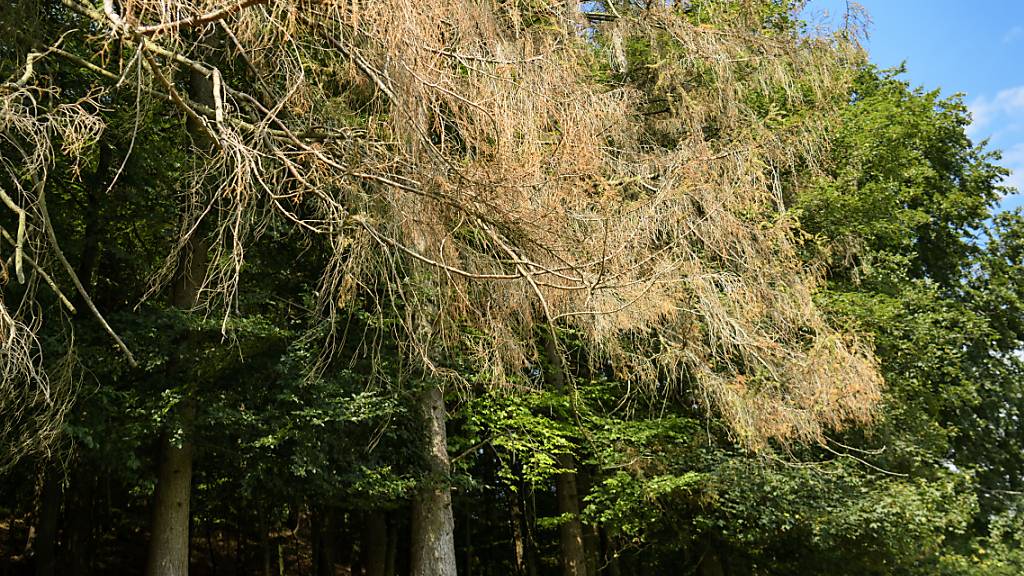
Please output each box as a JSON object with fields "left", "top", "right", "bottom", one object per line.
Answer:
{"left": 6, "top": 0, "right": 881, "bottom": 574}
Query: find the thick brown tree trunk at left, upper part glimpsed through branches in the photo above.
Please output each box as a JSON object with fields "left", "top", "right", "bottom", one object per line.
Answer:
{"left": 145, "top": 59, "right": 213, "bottom": 576}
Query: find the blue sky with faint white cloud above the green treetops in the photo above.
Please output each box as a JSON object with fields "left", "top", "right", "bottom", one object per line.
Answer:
{"left": 807, "top": 0, "right": 1024, "bottom": 208}
